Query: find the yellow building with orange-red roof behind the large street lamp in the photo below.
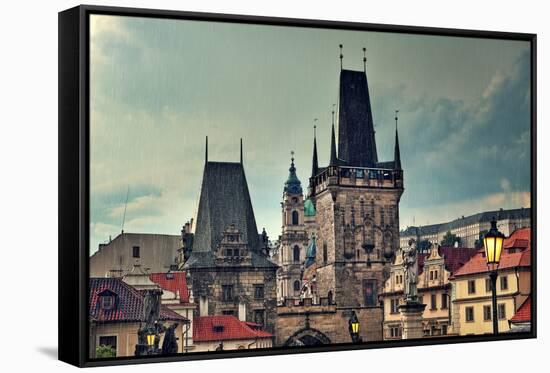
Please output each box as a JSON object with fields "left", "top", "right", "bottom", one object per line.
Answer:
{"left": 451, "top": 228, "right": 531, "bottom": 335}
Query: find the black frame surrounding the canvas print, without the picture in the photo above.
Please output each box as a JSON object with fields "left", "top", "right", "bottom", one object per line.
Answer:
{"left": 58, "top": 5, "right": 537, "bottom": 367}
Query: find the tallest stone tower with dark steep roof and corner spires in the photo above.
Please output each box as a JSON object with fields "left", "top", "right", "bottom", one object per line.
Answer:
{"left": 309, "top": 59, "right": 403, "bottom": 339}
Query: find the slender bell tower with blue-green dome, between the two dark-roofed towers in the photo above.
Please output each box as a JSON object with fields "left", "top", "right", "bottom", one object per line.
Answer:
{"left": 277, "top": 157, "right": 315, "bottom": 302}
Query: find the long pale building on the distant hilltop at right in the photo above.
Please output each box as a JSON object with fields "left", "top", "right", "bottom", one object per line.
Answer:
{"left": 400, "top": 208, "right": 531, "bottom": 247}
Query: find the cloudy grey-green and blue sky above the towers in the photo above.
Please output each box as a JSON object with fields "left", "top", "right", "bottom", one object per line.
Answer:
{"left": 90, "top": 16, "right": 530, "bottom": 252}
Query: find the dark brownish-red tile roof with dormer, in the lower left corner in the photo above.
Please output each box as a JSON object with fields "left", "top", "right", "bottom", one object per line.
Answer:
{"left": 88, "top": 278, "right": 187, "bottom": 322}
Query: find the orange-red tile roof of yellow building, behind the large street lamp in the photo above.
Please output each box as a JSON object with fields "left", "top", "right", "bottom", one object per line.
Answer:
{"left": 453, "top": 228, "right": 531, "bottom": 277}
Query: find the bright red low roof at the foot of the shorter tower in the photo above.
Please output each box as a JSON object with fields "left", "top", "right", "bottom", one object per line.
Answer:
{"left": 193, "top": 315, "right": 273, "bottom": 342}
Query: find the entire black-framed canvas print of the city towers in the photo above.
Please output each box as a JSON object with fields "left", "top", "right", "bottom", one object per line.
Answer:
{"left": 59, "top": 6, "right": 537, "bottom": 366}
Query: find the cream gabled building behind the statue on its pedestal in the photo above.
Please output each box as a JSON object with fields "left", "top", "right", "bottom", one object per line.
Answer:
{"left": 380, "top": 244, "right": 476, "bottom": 340}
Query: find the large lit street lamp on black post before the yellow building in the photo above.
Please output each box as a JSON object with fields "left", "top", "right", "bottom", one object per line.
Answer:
{"left": 483, "top": 218, "right": 504, "bottom": 334}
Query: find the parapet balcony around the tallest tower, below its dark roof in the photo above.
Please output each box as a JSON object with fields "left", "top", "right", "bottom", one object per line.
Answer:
{"left": 310, "top": 166, "right": 403, "bottom": 195}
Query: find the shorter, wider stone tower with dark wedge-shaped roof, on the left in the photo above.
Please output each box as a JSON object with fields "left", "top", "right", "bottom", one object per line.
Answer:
{"left": 181, "top": 146, "right": 277, "bottom": 333}
